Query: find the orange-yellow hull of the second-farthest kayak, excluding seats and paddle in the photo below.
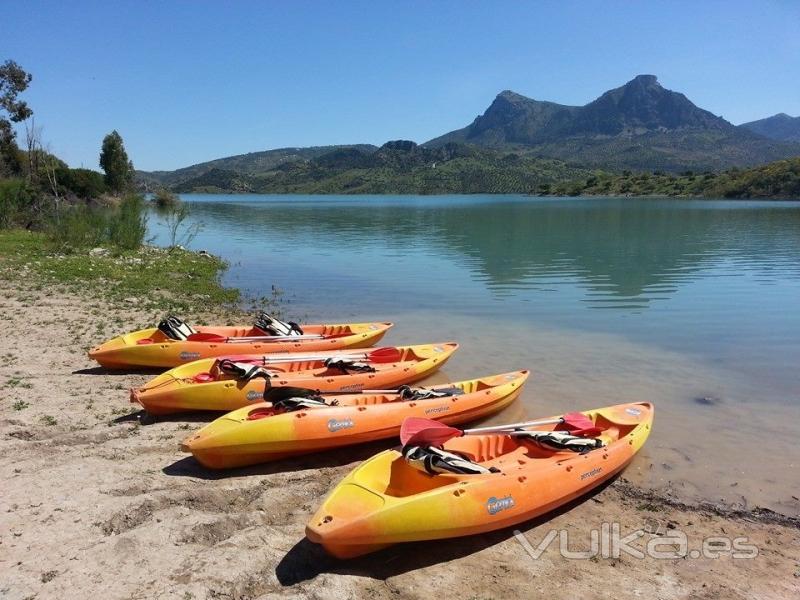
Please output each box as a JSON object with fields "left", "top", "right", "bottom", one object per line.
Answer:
{"left": 131, "top": 342, "right": 458, "bottom": 415}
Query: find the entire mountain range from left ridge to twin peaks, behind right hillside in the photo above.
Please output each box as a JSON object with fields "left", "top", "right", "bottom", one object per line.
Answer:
{"left": 137, "top": 75, "right": 800, "bottom": 193}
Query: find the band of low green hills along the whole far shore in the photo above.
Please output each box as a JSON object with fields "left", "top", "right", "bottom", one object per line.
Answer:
{"left": 139, "top": 140, "right": 800, "bottom": 199}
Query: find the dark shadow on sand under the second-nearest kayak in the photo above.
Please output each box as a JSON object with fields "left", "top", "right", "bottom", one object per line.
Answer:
{"left": 161, "top": 440, "right": 395, "bottom": 480}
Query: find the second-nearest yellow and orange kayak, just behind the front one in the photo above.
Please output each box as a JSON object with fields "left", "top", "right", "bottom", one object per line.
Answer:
{"left": 181, "top": 371, "right": 528, "bottom": 469}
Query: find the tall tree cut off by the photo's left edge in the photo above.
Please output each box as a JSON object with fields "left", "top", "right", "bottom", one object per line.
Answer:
{"left": 0, "top": 60, "right": 33, "bottom": 175}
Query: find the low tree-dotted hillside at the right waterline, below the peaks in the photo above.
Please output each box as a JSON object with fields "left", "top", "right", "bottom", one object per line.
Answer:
{"left": 537, "top": 158, "right": 800, "bottom": 200}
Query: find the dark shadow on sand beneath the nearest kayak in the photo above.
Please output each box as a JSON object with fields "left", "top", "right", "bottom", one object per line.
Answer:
{"left": 275, "top": 476, "right": 617, "bottom": 586}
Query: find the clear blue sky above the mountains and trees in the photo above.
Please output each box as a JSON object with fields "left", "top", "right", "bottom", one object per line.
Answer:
{"left": 0, "top": 0, "right": 800, "bottom": 170}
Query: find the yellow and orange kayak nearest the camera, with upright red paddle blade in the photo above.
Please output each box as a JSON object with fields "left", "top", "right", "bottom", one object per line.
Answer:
{"left": 306, "top": 403, "right": 653, "bottom": 558}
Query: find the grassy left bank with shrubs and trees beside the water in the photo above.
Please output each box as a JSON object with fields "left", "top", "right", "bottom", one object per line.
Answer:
{"left": 0, "top": 61, "right": 241, "bottom": 313}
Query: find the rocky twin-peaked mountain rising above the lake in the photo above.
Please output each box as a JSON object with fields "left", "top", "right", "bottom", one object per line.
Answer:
{"left": 425, "top": 75, "right": 800, "bottom": 171}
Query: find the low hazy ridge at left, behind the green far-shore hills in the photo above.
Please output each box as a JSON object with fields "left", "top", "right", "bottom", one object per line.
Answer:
{"left": 136, "top": 144, "right": 377, "bottom": 187}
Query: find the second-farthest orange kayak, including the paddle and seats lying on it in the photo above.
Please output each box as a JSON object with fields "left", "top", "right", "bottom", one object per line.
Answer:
{"left": 131, "top": 342, "right": 458, "bottom": 415}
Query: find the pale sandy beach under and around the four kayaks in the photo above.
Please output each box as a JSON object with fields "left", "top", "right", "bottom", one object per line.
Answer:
{"left": 0, "top": 282, "right": 800, "bottom": 600}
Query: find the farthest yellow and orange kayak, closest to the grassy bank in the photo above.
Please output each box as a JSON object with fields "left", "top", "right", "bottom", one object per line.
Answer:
{"left": 89, "top": 323, "right": 392, "bottom": 369}
